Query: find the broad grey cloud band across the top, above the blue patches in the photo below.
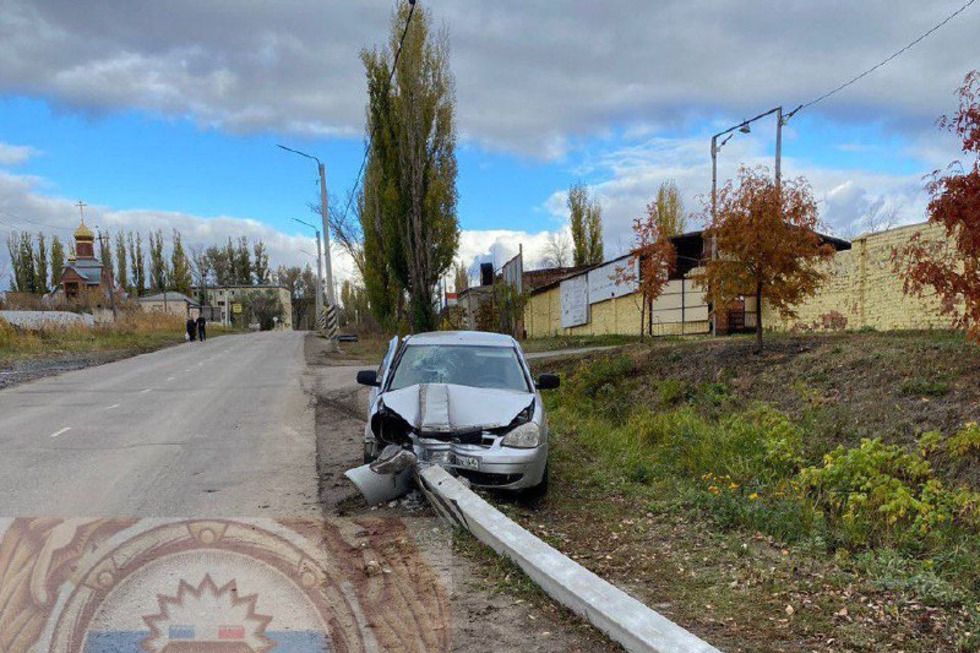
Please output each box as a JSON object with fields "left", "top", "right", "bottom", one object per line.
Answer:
{"left": 0, "top": 0, "right": 980, "bottom": 158}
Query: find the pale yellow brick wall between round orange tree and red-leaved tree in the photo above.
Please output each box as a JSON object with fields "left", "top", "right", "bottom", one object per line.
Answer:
{"left": 762, "top": 224, "right": 950, "bottom": 330}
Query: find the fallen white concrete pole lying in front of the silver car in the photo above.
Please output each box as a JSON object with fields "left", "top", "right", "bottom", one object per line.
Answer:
{"left": 417, "top": 465, "right": 720, "bottom": 653}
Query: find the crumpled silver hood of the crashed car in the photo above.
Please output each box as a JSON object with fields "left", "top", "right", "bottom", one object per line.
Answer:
{"left": 381, "top": 383, "right": 534, "bottom": 433}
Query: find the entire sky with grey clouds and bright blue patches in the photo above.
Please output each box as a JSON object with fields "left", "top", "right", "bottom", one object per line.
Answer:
{"left": 0, "top": 0, "right": 980, "bottom": 286}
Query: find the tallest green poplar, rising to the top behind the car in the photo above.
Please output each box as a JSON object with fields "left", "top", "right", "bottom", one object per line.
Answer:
{"left": 358, "top": 2, "right": 459, "bottom": 331}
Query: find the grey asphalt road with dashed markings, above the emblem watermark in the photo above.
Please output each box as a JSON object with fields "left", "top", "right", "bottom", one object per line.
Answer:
{"left": 0, "top": 332, "right": 319, "bottom": 517}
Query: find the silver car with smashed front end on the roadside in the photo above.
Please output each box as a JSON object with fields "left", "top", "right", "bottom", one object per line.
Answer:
{"left": 357, "top": 331, "right": 559, "bottom": 493}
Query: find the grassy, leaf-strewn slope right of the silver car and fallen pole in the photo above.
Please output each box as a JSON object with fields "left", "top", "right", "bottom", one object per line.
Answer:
{"left": 509, "top": 332, "right": 980, "bottom": 653}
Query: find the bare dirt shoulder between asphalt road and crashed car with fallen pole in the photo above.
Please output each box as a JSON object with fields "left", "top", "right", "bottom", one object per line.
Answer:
{"left": 306, "top": 336, "right": 622, "bottom": 653}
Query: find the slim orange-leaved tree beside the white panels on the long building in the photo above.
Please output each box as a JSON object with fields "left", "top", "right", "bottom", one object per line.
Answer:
{"left": 615, "top": 202, "right": 677, "bottom": 339}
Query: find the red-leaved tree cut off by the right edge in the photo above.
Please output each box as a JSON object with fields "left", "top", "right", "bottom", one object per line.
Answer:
{"left": 892, "top": 70, "right": 980, "bottom": 341}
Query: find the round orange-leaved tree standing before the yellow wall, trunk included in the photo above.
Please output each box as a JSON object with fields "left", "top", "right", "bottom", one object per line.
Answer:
{"left": 694, "top": 167, "right": 834, "bottom": 349}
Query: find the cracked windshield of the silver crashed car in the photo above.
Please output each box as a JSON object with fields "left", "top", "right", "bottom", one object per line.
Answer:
{"left": 388, "top": 345, "right": 529, "bottom": 392}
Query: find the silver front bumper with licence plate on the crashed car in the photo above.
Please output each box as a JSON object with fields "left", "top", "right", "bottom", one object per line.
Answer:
{"left": 415, "top": 439, "right": 548, "bottom": 490}
